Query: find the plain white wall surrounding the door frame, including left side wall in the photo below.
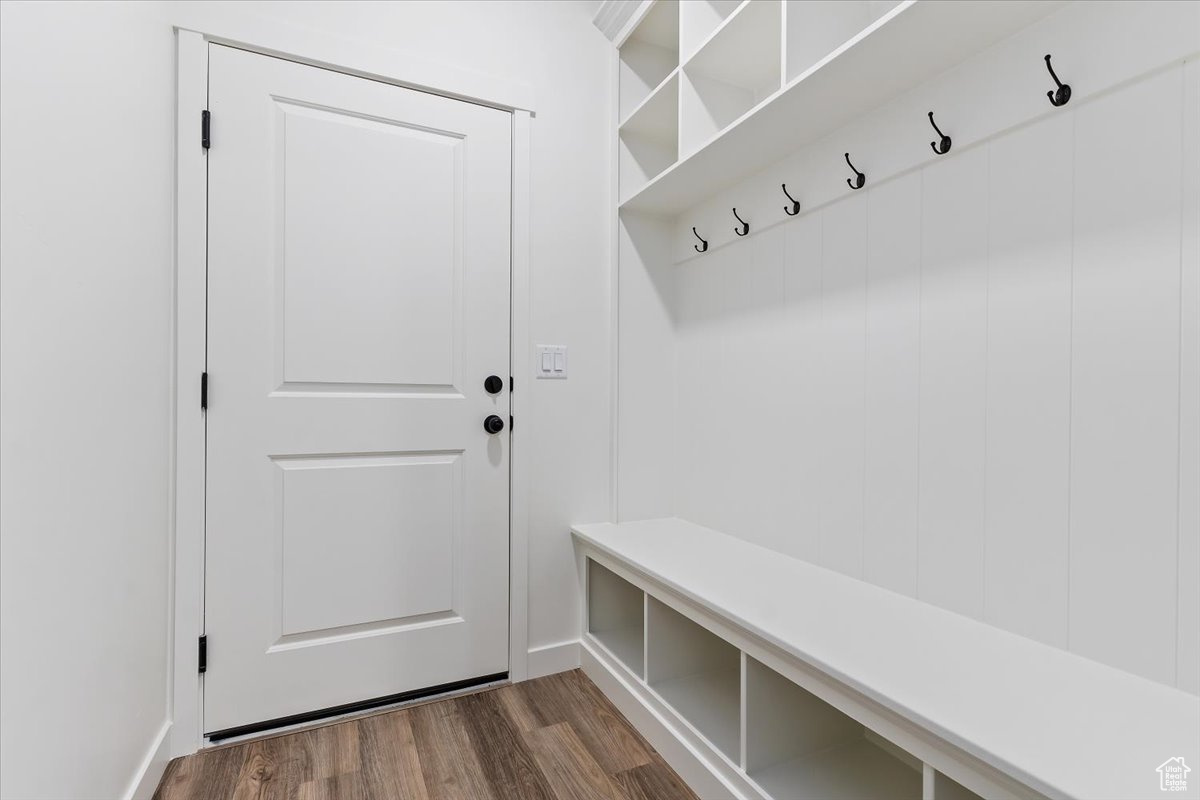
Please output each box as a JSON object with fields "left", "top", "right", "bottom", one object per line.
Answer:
{"left": 0, "top": 2, "right": 611, "bottom": 798}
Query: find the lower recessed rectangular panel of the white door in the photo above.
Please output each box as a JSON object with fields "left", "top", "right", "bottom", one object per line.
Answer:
{"left": 275, "top": 453, "right": 463, "bottom": 637}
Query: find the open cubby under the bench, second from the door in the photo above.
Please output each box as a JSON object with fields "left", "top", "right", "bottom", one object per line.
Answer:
{"left": 646, "top": 597, "right": 742, "bottom": 764}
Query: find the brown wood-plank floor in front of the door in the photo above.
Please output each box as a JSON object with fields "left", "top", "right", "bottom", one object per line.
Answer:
{"left": 155, "top": 669, "right": 696, "bottom": 800}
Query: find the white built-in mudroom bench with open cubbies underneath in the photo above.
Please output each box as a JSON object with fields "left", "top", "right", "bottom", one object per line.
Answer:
{"left": 572, "top": 518, "right": 1200, "bottom": 800}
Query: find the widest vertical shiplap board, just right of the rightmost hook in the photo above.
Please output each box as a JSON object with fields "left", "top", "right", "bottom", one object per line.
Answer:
{"left": 1070, "top": 68, "right": 1182, "bottom": 682}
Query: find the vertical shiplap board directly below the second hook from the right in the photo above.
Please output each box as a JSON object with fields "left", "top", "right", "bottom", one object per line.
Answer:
{"left": 918, "top": 148, "right": 988, "bottom": 616}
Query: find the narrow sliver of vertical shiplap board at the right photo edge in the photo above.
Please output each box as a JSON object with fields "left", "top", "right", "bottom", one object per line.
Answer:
{"left": 1176, "top": 60, "right": 1200, "bottom": 694}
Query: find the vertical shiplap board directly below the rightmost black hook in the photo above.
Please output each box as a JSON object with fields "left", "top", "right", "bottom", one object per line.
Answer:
{"left": 984, "top": 114, "right": 1074, "bottom": 648}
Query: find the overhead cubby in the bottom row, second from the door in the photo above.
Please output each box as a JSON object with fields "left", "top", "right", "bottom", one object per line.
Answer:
{"left": 679, "top": 0, "right": 782, "bottom": 157}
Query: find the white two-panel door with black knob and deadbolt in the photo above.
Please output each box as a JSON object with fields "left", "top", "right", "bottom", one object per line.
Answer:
{"left": 204, "top": 46, "right": 511, "bottom": 733}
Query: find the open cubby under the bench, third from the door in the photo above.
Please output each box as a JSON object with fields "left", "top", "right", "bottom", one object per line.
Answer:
{"left": 745, "top": 656, "right": 923, "bottom": 800}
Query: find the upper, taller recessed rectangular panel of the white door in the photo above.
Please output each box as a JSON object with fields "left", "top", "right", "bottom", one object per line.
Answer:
{"left": 276, "top": 103, "right": 464, "bottom": 387}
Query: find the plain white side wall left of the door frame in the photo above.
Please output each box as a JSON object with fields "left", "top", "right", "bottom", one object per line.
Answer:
{"left": 0, "top": 2, "right": 174, "bottom": 799}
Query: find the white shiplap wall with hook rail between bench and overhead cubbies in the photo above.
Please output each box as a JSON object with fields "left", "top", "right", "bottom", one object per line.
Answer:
{"left": 619, "top": 4, "right": 1200, "bottom": 693}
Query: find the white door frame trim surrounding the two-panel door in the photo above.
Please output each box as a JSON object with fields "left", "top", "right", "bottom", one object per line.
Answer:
{"left": 168, "top": 28, "right": 533, "bottom": 758}
